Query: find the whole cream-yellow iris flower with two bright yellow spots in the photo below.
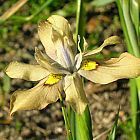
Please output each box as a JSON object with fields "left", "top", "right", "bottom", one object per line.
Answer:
{"left": 6, "top": 15, "right": 140, "bottom": 114}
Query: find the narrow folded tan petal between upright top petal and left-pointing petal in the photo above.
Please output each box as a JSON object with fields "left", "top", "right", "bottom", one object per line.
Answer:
{"left": 35, "top": 48, "right": 69, "bottom": 74}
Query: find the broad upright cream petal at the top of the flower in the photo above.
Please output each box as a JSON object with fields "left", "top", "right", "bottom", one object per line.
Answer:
{"left": 38, "top": 15, "right": 76, "bottom": 60}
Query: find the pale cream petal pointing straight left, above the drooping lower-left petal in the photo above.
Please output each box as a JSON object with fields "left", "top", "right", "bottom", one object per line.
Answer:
{"left": 5, "top": 62, "right": 49, "bottom": 81}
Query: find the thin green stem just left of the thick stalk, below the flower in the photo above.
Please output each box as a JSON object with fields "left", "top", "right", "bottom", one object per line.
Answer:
{"left": 59, "top": 93, "right": 73, "bottom": 140}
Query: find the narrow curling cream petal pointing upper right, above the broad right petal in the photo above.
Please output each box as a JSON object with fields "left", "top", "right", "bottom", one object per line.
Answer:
{"left": 83, "top": 36, "right": 122, "bottom": 56}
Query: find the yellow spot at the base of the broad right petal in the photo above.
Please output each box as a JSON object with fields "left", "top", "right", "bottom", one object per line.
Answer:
{"left": 81, "top": 60, "right": 98, "bottom": 70}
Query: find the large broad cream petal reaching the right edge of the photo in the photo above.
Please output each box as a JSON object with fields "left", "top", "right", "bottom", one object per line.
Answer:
{"left": 78, "top": 53, "right": 140, "bottom": 84}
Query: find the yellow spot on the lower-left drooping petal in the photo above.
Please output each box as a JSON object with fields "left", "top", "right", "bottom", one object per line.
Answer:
{"left": 45, "top": 74, "right": 63, "bottom": 85}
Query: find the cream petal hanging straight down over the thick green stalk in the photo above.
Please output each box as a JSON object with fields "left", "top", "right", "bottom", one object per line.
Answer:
{"left": 64, "top": 74, "right": 88, "bottom": 114}
